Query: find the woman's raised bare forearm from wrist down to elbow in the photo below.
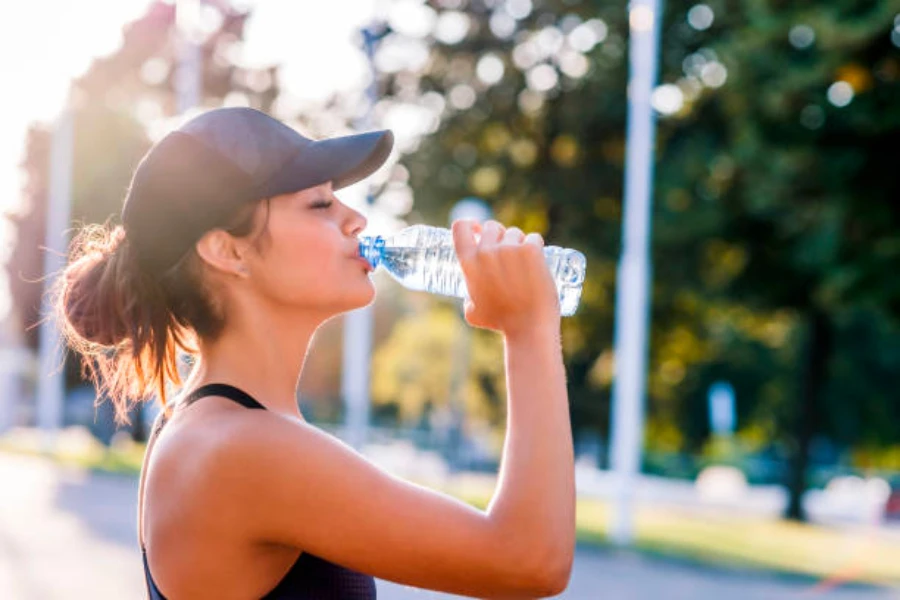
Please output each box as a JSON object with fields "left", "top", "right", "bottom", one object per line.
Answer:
{"left": 488, "top": 327, "right": 575, "bottom": 560}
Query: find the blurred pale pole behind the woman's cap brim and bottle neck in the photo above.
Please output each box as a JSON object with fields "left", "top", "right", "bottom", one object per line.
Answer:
{"left": 341, "top": 13, "right": 378, "bottom": 452}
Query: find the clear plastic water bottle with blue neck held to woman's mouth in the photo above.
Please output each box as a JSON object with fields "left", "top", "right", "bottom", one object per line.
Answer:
{"left": 359, "top": 225, "right": 587, "bottom": 317}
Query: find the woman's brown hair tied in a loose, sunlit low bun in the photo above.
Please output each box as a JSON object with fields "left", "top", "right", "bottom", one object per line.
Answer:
{"left": 52, "top": 199, "right": 269, "bottom": 423}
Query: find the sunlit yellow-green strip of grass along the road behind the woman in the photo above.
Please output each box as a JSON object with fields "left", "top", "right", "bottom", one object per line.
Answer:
{"left": 0, "top": 433, "right": 900, "bottom": 588}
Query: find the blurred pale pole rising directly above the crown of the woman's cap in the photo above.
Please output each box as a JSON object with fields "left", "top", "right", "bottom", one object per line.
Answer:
{"left": 175, "top": 0, "right": 203, "bottom": 114}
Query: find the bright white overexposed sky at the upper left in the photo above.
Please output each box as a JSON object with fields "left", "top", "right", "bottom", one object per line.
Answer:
{"left": 0, "top": 0, "right": 384, "bottom": 326}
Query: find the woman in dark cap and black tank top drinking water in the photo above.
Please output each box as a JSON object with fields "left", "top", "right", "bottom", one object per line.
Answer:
{"left": 58, "top": 108, "right": 575, "bottom": 600}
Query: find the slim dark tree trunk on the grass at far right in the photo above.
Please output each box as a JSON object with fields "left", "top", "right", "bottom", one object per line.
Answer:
{"left": 785, "top": 309, "right": 832, "bottom": 521}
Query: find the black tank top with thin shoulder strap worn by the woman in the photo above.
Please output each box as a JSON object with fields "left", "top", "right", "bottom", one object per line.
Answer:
{"left": 141, "top": 383, "right": 375, "bottom": 600}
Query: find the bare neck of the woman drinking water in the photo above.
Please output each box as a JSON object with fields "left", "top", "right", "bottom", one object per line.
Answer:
{"left": 184, "top": 304, "right": 324, "bottom": 419}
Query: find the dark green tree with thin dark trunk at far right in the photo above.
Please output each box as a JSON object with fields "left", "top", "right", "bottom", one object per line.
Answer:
{"left": 660, "top": 1, "right": 900, "bottom": 518}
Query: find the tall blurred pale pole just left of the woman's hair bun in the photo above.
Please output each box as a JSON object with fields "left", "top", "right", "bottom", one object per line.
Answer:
{"left": 37, "top": 101, "right": 73, "bottom": 452}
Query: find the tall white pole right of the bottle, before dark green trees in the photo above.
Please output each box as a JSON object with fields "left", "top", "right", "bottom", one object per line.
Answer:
{"left": 610, "top": 0, "right": 661, "bottom": 545}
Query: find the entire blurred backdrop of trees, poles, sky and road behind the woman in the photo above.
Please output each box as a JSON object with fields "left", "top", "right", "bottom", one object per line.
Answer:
{"left": 0, "top": 0, "right": 900, "bottom": 600}
